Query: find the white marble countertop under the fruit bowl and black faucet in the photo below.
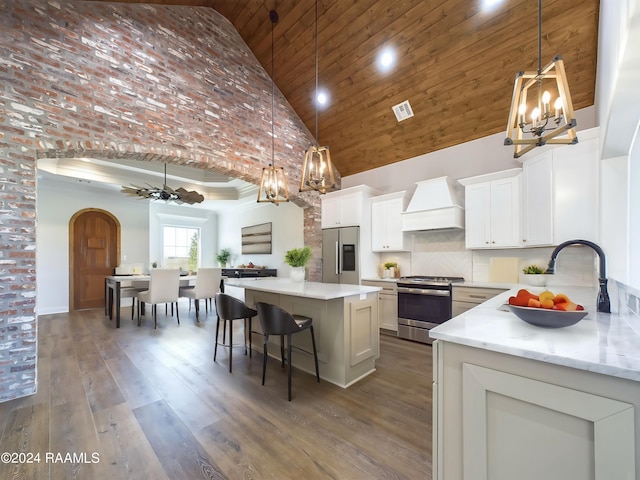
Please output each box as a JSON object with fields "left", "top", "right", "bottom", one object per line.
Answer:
{"left": 429, "top": 287, "right": 640, "bottom": 381}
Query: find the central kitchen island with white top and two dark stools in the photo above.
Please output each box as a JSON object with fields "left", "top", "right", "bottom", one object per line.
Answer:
{"left": 225, "top": 278, "right": 380, "bottom": 388}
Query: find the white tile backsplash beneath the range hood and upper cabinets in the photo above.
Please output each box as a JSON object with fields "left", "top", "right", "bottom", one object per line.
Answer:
{"left": 380, "top": 230, "right": 598, "bottom": 286}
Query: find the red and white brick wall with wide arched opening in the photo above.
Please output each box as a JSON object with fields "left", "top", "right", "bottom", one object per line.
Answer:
{"left": 0, "top": 0, "right": 338, "bottom": 401}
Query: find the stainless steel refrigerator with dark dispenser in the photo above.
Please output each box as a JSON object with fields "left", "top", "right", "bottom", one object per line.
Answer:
{"left": 322, "top": 227, "right": 360, "bottom": 285}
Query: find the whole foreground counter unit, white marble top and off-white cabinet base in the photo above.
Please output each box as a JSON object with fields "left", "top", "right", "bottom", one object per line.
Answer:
{"left": 430, "top": 287, "right": 640, "bottom": 480}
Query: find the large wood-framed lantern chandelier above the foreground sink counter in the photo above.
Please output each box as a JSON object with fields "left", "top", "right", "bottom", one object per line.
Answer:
{"left": 504, "top": 0, "right": 578, "bottom": 158}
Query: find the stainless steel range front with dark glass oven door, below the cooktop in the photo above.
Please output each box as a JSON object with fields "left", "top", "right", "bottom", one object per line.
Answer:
{"left": 398, "top": 286, "right": 451, "bottom": 343}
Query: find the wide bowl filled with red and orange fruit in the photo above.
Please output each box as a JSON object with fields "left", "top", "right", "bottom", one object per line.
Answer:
{"left": 509, "top": 289, "right": 587, "bottom": 328}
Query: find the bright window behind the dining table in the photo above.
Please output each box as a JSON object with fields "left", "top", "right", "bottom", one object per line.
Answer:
{"left": 162, "top": 225, "right": 200, "bottom": 271}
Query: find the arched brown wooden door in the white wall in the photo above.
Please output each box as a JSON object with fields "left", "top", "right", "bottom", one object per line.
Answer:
{"left": 69, "top": 209, "right": 120, "bottom": 311}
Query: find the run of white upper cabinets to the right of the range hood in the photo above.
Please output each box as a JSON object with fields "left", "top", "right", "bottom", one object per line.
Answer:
{"left": 460, "top": 128, "right": 599, "bottom": 249}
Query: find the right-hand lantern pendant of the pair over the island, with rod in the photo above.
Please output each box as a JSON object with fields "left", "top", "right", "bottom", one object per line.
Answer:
{"left": 300, "top": 0, "right": 336, "bottom": 194}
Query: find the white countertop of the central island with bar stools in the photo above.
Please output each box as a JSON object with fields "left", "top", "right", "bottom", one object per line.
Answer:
{"left": 224, "top": 277, "right": 381, "bottom": 300}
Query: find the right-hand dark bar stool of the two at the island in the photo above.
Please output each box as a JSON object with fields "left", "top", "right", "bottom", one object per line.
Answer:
{"left": 256, "top": 302, "right": 320, "bottom": 401}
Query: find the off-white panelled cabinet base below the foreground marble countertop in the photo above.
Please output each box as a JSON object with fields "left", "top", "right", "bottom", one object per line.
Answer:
{"left": 433, "top": 340, "right": 640, "bottom": 480}
